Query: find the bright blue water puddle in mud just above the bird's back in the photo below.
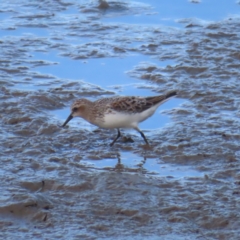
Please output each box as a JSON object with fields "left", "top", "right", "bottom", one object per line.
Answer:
{"left": 33, "top": 52, "right": 174, "bottom": 96}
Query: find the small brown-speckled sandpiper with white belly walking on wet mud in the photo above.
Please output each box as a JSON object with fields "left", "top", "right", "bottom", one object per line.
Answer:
{"left": 62, "top": 91, "right": 177, "bottom": 146}
